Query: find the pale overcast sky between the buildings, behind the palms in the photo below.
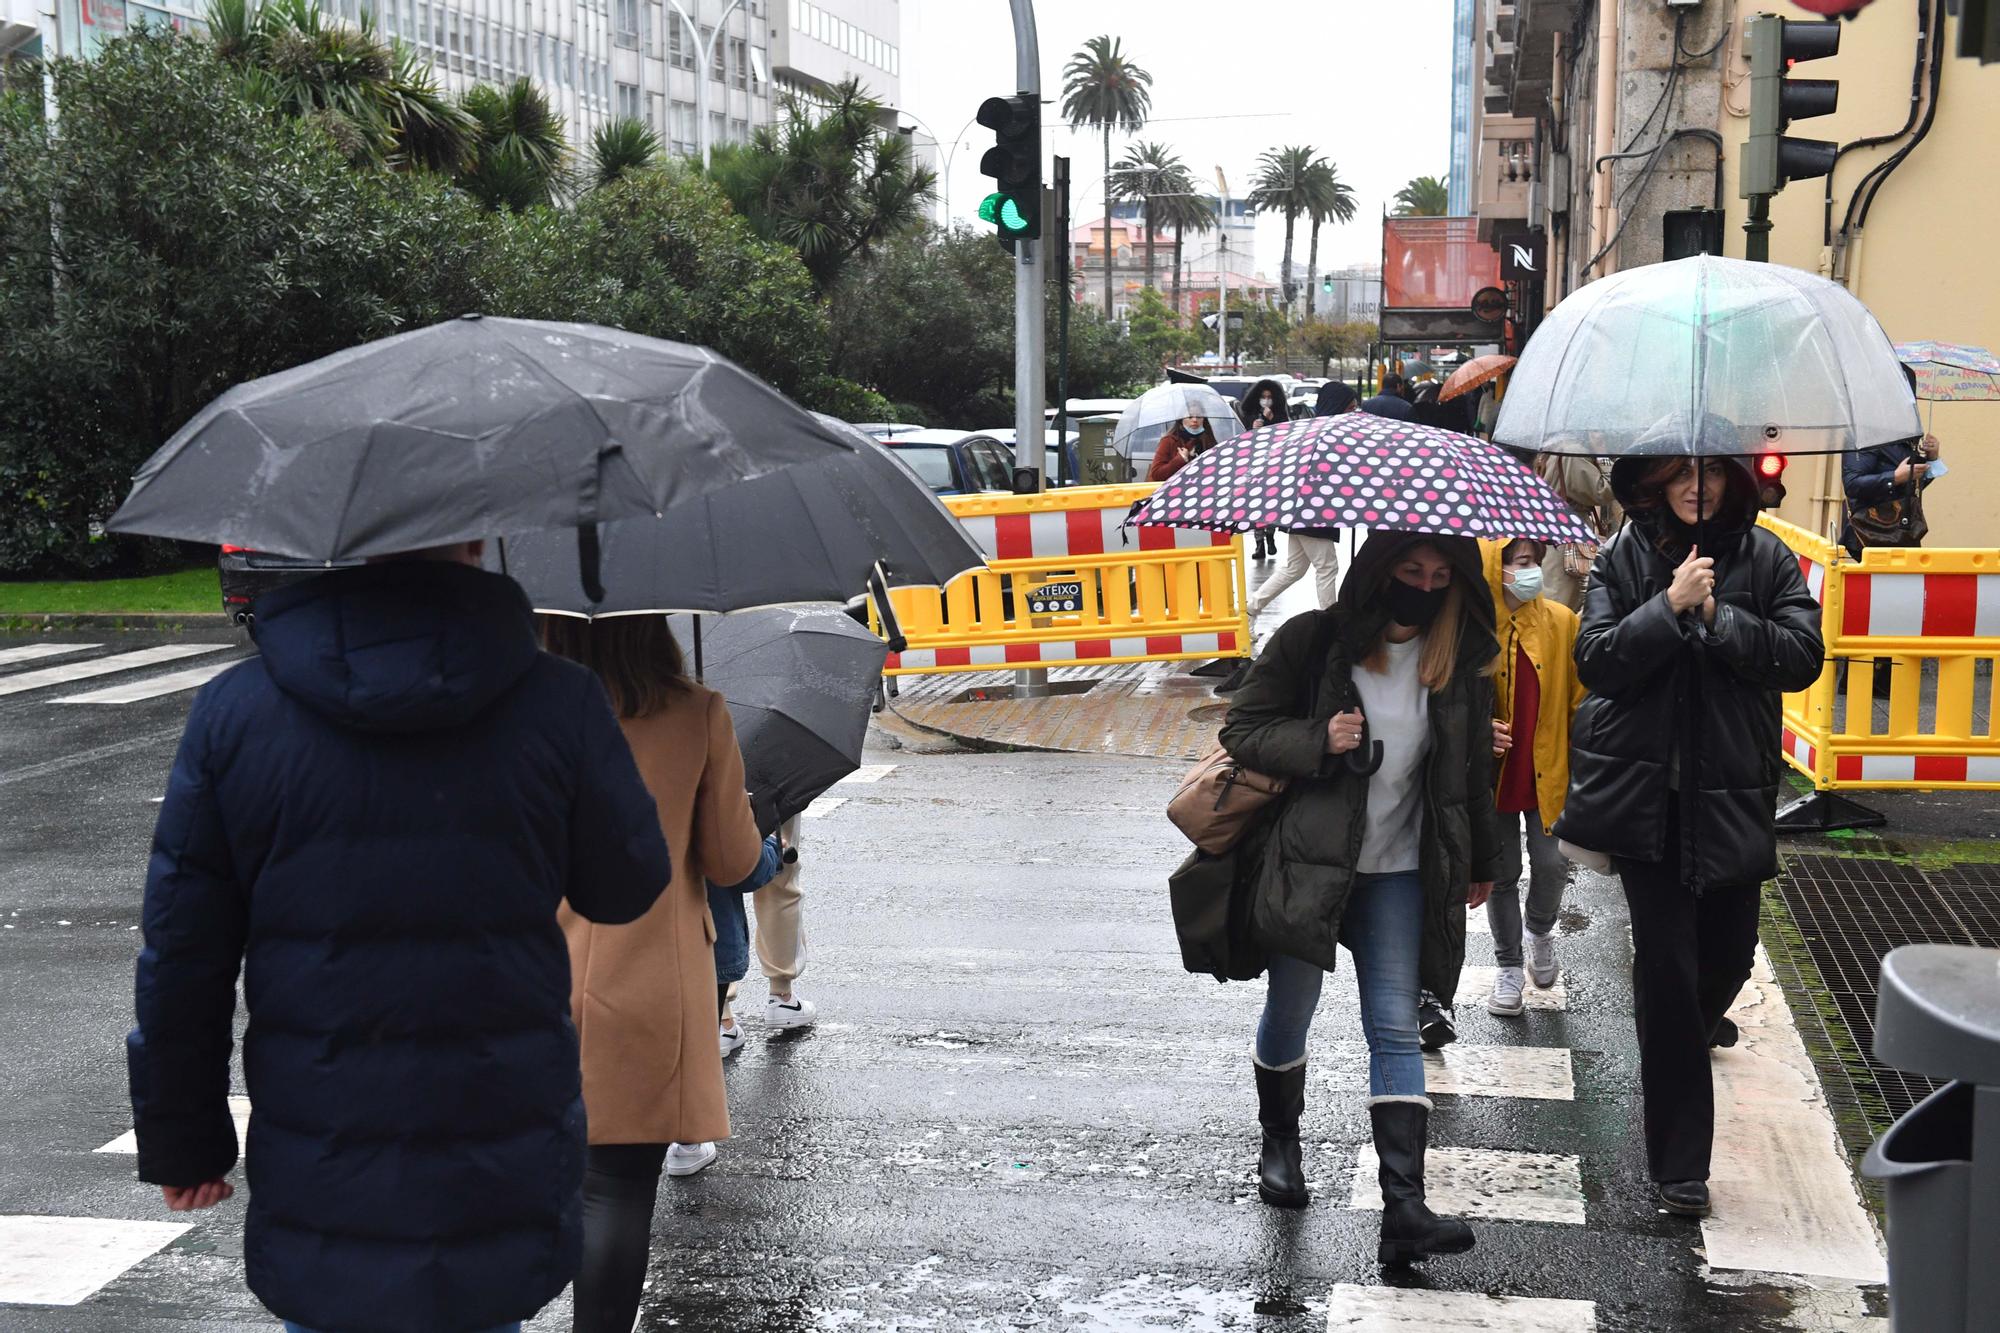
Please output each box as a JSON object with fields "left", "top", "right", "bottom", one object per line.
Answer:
{"left": 902, "top": 0, "right": 1452, "bottom": 278}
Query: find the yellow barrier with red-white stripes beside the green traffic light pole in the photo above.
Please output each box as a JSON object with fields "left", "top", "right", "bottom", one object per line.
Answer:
{"left": 886, "top": 484, "right": 1250, "bottom": 675}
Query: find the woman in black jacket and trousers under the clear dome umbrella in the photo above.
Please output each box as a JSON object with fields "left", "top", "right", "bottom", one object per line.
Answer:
{"left": 1556, "top": 422, "right": 1824, "bottom": 1217}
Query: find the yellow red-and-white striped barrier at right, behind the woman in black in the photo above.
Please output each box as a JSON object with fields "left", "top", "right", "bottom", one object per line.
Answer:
{"left": 1760, "top": 514, "right": 2000, "bottom": 829}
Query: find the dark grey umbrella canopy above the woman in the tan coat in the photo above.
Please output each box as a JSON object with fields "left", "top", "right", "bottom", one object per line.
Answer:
{"left": 486, "top": 416, "right": 986, "bottom": 616}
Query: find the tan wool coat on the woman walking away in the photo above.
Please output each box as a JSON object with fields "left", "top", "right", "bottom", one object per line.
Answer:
{"left": 560, "top": 687, "right": 762, "bottom": 1143}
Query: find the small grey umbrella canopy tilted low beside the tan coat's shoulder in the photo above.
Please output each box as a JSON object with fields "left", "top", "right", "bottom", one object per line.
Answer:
{"left": 674, "top": 606, "right": 888, "bottom": 833}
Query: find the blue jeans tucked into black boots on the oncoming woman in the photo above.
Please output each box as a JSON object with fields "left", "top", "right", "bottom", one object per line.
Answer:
{"left": 1254, "top": 871, "right": 1424, "bottom": 1097}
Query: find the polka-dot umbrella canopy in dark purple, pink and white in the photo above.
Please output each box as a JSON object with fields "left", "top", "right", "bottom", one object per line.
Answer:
{"left": 1134, "top": 412, "right": 1594, "bottom": 542}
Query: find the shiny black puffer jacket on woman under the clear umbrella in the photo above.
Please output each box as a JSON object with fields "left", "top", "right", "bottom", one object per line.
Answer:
{"left": 1556, "top": 456, "right": 1824, "bottom": 891}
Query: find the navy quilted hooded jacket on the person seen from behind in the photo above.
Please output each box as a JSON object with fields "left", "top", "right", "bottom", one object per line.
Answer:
{"left": 128, "top": 562, "right": 672, "bottom": 1333}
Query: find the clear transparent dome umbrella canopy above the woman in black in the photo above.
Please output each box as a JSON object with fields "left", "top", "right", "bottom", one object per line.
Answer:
{"left": 1494, "top": 254, "right": 1922, "bottom": 456}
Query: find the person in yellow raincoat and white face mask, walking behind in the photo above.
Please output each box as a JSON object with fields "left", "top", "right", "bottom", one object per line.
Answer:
{"left": 1480, "top": 540, "right": 1584, "bottom": 1019}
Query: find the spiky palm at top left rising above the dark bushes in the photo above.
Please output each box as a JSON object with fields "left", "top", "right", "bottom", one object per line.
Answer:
{"left": 208, "top": 0, "right": 474, "bottom": 172}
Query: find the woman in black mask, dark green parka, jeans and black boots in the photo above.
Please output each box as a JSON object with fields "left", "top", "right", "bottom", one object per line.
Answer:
{"left": 1222, "top": 530, "right": 1500, "bottom": 1263}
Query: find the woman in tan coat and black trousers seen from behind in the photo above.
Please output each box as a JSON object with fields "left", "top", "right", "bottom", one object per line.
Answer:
{"left": 544, "top": 616, "right": 764, "bottom": 1333}
